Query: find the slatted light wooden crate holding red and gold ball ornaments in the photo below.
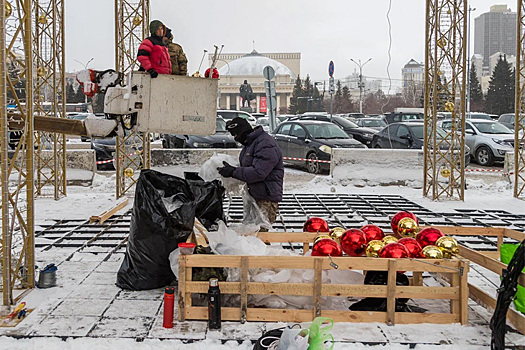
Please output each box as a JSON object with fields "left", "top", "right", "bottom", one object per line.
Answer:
{"left": 178, "top": 232, "right": 468, "bottom": 324}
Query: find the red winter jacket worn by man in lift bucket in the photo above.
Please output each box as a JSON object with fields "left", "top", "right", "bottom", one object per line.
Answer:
{"left": 137, "top": 35, "right": 171, "bottom": 74}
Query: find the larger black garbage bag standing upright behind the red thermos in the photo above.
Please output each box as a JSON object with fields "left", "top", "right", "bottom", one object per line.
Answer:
{"left": 117, "top": 170, "right": 197, "bottom": 290}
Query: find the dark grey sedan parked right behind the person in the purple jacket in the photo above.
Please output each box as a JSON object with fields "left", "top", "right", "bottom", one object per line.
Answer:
{"left": 272, "top": 120, "right": 365, "bottom": 174}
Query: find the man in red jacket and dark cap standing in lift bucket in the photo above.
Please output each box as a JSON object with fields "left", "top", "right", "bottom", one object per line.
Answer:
{"left": 137, "top": 20, "right": 171, "bottom": 78}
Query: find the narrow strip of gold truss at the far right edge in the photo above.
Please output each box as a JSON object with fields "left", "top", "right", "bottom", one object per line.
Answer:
{"left": 514, "top": 0, "right": 525, "bottom": 199}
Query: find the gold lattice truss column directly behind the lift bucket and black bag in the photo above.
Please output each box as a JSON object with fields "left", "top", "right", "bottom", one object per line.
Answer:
{"left": 115, "top": 0, "right": 151, "bottom": 198}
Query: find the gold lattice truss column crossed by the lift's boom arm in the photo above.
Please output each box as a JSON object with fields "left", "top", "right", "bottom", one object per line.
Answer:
{"left": 33, "top": 0, "right": 66, "bottom": 199}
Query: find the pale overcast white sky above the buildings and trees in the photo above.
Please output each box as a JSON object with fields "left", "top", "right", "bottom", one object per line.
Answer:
{"left": 65, "top": 0, "right": 516, "bottom": 88}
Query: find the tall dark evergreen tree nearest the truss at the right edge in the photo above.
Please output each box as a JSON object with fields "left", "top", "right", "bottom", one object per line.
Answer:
{"left": 485, "top": 56, "right": 515, "bottom": 115}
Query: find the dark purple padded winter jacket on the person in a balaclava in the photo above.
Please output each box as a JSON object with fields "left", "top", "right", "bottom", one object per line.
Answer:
{"left": 233, "top": 126, "right": 284, "bottom": 202}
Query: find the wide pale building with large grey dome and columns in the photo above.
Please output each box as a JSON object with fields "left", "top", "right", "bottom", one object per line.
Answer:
{"left": 208, "top": 50, "right": 301, "bottom": 114}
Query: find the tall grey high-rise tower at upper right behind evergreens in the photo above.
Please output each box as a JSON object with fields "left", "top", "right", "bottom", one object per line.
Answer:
{"left": 474, "top": 5, "right": 517, "bottom": 70}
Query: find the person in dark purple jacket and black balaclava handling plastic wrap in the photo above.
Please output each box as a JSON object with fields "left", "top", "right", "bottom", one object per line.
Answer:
{"left": 217, "top": 117, "right": 284, "bottom": 224}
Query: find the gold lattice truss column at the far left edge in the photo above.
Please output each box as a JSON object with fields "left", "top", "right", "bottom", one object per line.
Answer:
{"left": 0, "top": 0, "right": 35, "bottom": 305}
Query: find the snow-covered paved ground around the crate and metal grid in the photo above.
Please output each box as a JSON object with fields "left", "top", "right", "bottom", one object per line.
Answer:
{"left": 0, "top": 163, "right": 525, "bottom": 350}
